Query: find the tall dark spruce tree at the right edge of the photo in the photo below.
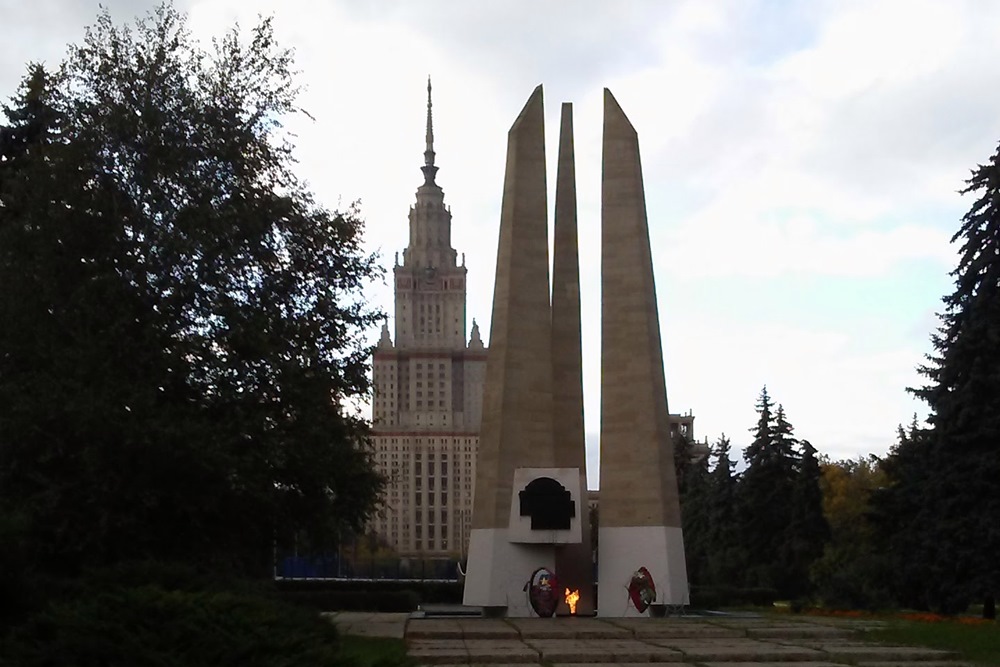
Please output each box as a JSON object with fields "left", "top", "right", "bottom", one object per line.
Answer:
{"left": 897, "top": 140, "right": 1000, "bottom": 611}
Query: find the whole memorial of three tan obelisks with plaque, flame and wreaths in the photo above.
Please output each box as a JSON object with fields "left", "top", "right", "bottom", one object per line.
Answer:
{"left": 464, "top": 86, "right": 688, "bottom": 616}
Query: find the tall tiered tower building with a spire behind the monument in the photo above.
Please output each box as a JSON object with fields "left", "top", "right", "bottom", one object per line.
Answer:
{"left": 372, "top": 81, "right": 486, "bottom": 558}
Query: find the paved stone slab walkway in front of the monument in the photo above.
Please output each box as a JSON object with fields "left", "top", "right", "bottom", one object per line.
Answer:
{"left": 332, "top": 612, "right": 968, "bottom": 667}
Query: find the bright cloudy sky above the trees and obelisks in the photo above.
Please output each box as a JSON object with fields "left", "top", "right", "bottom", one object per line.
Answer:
{"left": 0, "top": 0, "right": 1000, "bottom": 482}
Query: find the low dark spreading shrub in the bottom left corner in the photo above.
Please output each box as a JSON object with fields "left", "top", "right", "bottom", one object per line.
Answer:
{"left": 0, "top": 586, "right": 352, "bottom": 667}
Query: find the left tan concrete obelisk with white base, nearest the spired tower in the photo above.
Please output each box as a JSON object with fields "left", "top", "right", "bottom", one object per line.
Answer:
{"left": 463, "top": 86, "right": 568, "bottom": 616}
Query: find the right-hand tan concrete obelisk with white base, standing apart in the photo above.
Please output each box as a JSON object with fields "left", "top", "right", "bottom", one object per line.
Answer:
{"left": 598, "top": 89, "right": 689, "bottom": 616}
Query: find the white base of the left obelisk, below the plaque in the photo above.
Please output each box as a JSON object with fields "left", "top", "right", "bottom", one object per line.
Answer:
{"left": 462, "top": 528, "right": 558, "bottom": 618}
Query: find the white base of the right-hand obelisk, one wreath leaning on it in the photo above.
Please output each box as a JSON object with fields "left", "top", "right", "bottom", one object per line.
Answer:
{"left": 597, "top": 526, "right": 690, "bottom": 618}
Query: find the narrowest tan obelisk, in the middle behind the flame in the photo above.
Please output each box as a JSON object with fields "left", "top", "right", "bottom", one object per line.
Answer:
{"left": 552, "top": 102, "right": 594, "bottom": 615}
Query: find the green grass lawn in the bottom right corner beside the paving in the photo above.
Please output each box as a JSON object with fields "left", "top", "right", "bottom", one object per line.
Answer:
{"left": 865, "top": 619, "right": 1000, "bottom": 666}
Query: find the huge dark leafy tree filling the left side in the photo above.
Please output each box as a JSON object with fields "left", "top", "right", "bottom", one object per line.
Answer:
{"left": 0, "top": 5, "right": 381, "bottom": 572}
